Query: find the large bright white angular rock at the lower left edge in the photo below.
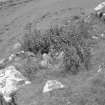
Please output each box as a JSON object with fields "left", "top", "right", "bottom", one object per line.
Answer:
{"left": 0, "top": 65, "right": 30, "bottom": 102}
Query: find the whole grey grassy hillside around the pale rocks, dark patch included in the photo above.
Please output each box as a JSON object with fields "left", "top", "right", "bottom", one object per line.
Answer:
{"left": 0, "top": 0, "right": 105, "bottom": 105}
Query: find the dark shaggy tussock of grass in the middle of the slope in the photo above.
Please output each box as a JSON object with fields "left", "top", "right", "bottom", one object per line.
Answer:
{"left": 22, "top": 20, "right": 91, "bottom": 74}
